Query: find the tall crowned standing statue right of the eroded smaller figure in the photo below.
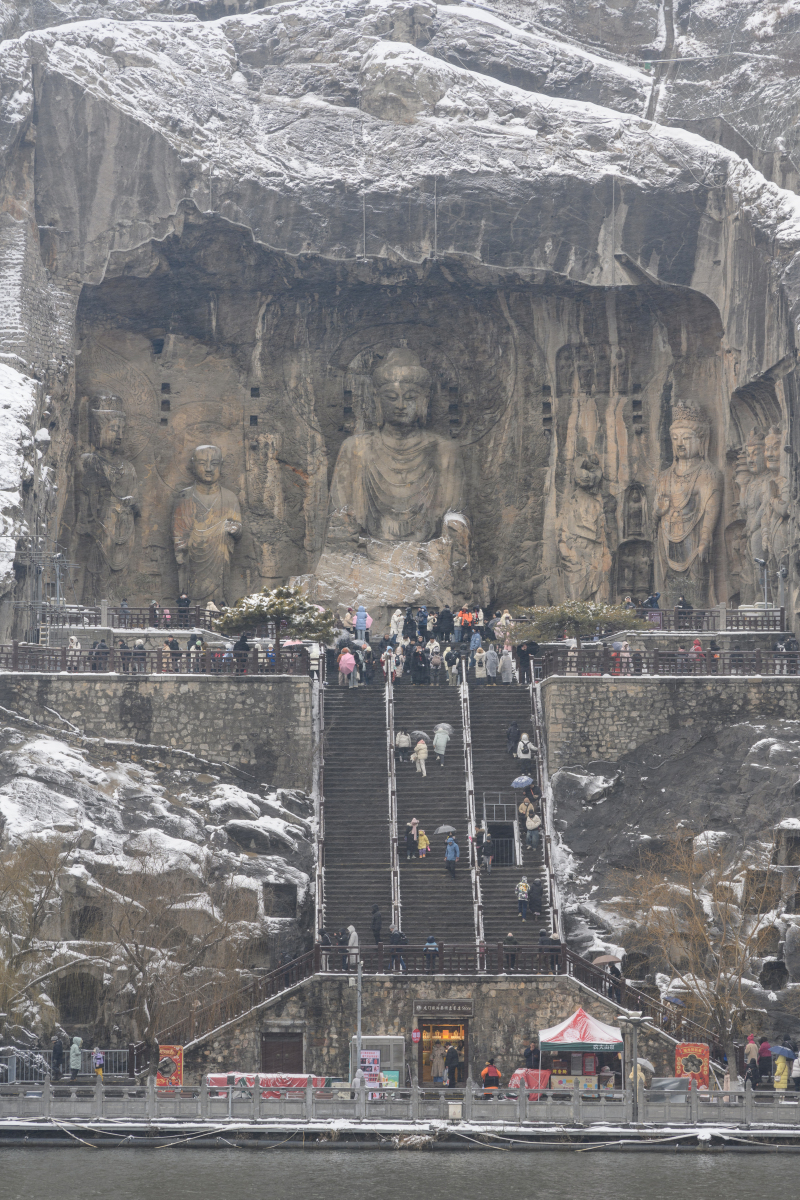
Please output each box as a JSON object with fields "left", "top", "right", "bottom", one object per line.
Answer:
{"left": 655, "top": 403, "right": 723, "bottom": 608}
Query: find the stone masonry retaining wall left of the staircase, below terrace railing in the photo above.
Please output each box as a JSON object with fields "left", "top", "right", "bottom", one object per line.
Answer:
{"left": 0, "top": 674, "right": 312, "bottom": 792}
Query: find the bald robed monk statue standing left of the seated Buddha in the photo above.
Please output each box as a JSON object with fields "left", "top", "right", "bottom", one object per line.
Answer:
{"left": 173, "top": 445, "right": 242, "bottom": 604}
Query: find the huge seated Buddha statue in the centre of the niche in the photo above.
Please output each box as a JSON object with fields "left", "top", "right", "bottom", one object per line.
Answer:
{"left": 314, "top": 349, "right": 470, "bottom": 605}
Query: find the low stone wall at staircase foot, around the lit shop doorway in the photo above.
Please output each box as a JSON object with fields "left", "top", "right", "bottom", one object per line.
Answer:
{"left": 185, "top": 976, "right": 675, "bottom": 1082}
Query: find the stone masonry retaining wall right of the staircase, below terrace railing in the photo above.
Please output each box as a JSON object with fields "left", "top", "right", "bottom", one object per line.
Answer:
{"left": 542, "top": 676, "right": 800, "bottom": 773}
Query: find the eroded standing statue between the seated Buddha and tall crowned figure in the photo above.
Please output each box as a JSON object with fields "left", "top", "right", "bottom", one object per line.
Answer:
{"left": 557, "top": 454, "right": 612, "bottom": 600}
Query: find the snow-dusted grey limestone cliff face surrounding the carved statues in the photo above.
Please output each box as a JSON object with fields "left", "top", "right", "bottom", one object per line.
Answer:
{"left": 0, "top": 0, "right": 800, "bottom": 629}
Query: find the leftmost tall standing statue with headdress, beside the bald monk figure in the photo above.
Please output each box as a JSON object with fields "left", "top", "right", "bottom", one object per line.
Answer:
{"left": 78, "top": 396, "right": 140, "bottom": 600}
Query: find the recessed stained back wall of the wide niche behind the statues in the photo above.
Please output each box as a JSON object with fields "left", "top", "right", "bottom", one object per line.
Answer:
{"left": 61, "top": 212, "right": 738, "bottom": 605}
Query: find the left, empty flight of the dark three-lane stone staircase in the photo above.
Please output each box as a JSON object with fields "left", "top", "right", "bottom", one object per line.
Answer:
{"left": 324, "top": 683, "right": 393, "bottom": 946}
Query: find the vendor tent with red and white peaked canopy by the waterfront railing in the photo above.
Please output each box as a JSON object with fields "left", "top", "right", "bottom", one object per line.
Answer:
{"left": 539, "top": 1008, "right": 622, "bottom": 1091}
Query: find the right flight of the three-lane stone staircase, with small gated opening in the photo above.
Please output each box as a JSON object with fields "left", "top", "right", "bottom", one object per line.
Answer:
{"left": 469, "top": 683, "right": 549, "bottom": 946}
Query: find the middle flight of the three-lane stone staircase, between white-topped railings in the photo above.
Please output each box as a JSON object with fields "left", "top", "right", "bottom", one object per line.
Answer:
{"left": 395, "top": 679, "right": 475, "bottom": 946}
